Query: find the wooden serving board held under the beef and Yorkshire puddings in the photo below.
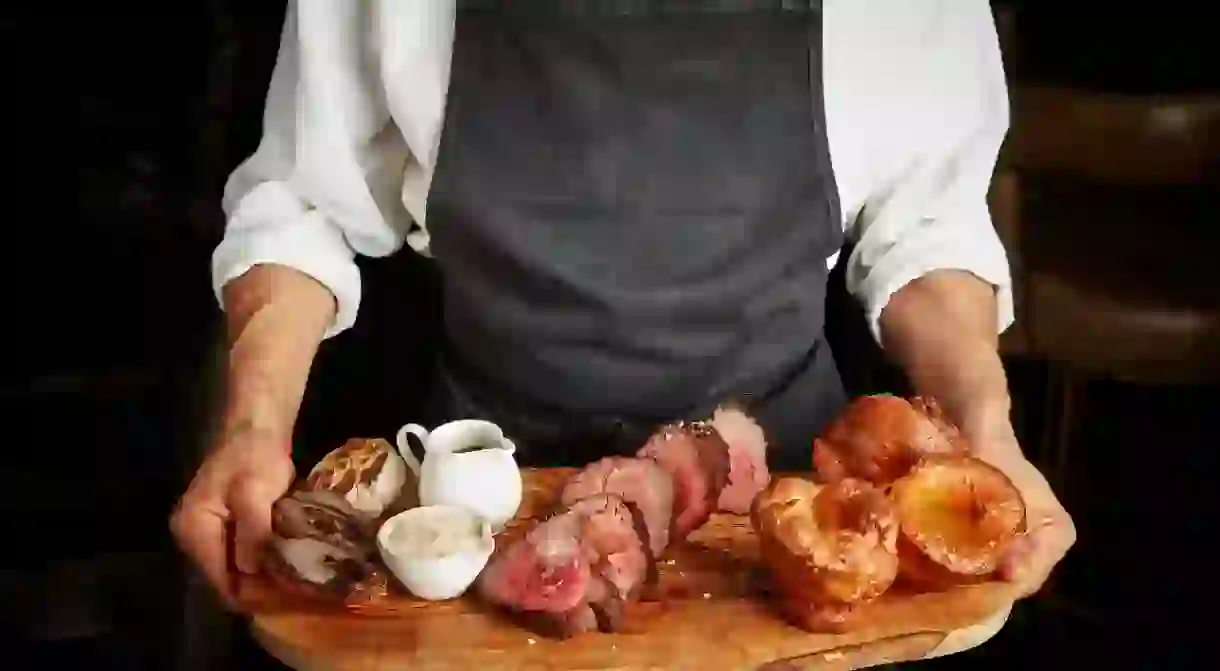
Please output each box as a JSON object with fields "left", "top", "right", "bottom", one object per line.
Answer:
{"left": 240, "top": 468, "right": 1013, "bottom": 671}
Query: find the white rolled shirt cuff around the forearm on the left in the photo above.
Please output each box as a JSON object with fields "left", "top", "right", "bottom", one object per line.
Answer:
{"left": 212, "top": 183, "right": 361, "bottom": 338}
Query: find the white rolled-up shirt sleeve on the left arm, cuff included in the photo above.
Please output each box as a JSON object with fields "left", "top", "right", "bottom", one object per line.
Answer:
{"left": 212, "top": 1, "right": 410, "bottom": 337}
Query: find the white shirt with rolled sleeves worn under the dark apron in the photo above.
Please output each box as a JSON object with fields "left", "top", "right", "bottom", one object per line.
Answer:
{"left": 212, "top": 0, "right": 1013, "bottom": 344}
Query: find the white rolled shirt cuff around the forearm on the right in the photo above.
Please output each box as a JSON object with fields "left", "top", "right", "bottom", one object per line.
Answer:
{"left": 860, "top": 220, "right": 1015, "bottom": 344}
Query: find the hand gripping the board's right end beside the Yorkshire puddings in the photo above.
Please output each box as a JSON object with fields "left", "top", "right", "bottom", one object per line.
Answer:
{"left": 978, "top": 439, "right": 1076, "bottom": 598}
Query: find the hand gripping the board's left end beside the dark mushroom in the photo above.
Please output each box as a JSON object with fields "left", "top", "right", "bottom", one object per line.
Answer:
{"left": 170, "top": 429, "right": 294, "bottom": 608}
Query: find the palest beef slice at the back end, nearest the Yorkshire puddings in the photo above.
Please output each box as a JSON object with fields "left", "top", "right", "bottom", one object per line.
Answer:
{"left": 709, "top": 406, "right": 771, "bottom": 515}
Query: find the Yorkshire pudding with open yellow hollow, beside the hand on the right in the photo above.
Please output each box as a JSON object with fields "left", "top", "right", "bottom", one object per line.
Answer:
{"left": 889, "top": 455, "right": 1025, "bottom": 589}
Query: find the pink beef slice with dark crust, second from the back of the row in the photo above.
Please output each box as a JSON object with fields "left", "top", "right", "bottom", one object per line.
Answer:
{"left": 637, "top": 422, "right": 730, "bottom": 542}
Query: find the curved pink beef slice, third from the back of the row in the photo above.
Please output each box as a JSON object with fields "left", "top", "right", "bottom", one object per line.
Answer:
{"left": 560, "top": 456, "right": 673, "bottom": 558}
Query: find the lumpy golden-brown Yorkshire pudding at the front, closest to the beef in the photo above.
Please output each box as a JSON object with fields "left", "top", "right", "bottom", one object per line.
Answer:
{"left": 750, "top": 477, "right": 898, "bottom": 631}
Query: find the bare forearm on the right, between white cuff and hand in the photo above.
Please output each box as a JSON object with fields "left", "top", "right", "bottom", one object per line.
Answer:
{"left": 880, "top": 271, "right": 1020, "bottom": 458}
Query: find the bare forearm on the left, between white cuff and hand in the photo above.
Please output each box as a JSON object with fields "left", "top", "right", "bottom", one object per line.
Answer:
{"left": 222, "top": 265, "right": 336, "bottom": 442}
